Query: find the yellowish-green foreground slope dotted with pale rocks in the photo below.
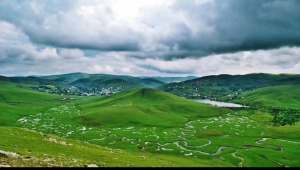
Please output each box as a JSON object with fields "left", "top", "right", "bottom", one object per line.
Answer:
{"left": 0, "top": 126, "right": 230, "bottom": 167}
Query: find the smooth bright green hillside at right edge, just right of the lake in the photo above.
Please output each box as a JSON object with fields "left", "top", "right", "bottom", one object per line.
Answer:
{"left": 233, "top": 85, "right": 300, "bottom": 108}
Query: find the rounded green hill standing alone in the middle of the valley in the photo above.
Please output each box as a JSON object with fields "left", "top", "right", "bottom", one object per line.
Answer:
{"left": 78, "top": 88, "right": 226, "bottom": 127}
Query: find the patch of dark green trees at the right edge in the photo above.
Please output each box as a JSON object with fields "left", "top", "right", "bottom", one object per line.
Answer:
{"left": 269, "top": 108, "right": 300, "bottom": 126}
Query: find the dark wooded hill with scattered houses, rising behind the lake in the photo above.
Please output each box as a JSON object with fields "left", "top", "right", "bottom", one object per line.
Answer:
{"left": 158, "top": 73, "right": 300, "bottom": 101}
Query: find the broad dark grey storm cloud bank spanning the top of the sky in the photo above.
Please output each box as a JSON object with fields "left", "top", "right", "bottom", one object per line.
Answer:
{"left": 0, "top": 0, "right": 300, "bottom": 60}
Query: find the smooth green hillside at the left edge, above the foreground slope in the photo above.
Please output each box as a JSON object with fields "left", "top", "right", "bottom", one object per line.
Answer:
{"left": 0, "top": 82, "right": 66, "bottom": 125}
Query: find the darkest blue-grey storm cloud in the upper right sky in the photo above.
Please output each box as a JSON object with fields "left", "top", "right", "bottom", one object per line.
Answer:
{"left": 159, "top": 0, "right": 300, "bottom": 57}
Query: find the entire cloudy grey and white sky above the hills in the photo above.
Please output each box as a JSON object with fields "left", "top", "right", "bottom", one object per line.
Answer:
{"left": 0, "top": 0, "right": 300, "bottom": 76}
